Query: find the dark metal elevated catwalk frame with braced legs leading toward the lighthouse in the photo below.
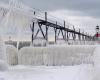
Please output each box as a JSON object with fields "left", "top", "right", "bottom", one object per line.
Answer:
{"left": 31, "top": 12, "right": 94, "bottom": 43}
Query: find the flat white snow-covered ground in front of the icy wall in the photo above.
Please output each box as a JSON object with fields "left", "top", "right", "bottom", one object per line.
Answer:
{"left": 0, "top": 65, "right": 95, "bottom": 80}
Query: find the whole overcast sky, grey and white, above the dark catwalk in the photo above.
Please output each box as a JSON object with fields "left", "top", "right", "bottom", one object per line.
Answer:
{"left": 22, "top": 0, "right": 100, "bottom": 33}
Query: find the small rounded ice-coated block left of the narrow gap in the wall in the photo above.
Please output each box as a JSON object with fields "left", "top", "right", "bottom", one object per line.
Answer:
{"left": 6, "top": 45, "right": 18, "bottom": 65}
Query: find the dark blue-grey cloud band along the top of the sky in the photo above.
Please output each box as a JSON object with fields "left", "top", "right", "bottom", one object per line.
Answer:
{"left": 23, "top": 0, "right": 100, "bottom": 18}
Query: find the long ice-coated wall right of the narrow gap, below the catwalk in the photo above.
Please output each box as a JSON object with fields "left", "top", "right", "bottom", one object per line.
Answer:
{"left": 18, "top": 46, "right": 95, "bottom": 66}
